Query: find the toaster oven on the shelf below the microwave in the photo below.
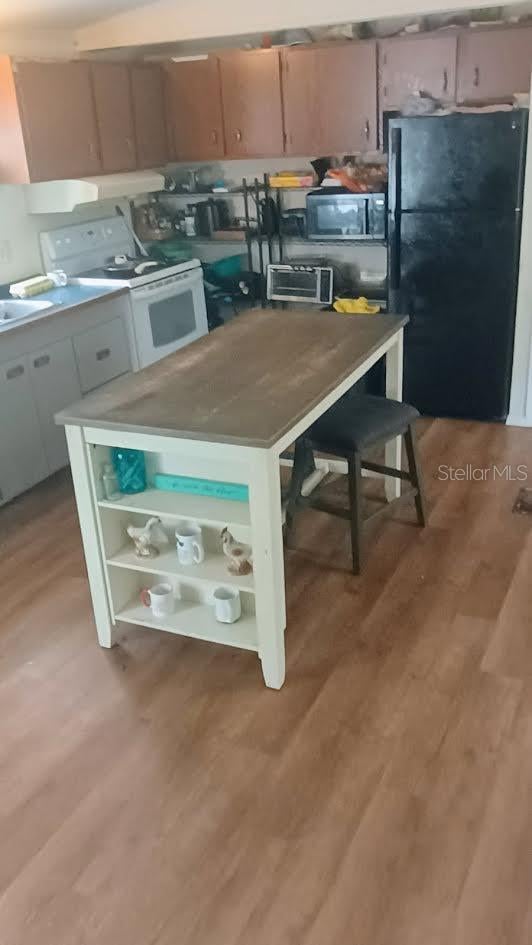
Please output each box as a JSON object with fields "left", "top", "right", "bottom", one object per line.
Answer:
{"left": 266, "top": 263, "right": 333, "bottom": 305}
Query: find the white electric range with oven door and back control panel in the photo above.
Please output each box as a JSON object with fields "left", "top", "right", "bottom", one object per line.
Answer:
{"left": 41, "top": 216, "right": 209, "bottom": 370}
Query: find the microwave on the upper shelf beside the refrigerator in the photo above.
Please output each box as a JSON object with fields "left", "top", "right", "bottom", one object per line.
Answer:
{"left": 307, "top": 187, "right": 386, "bottom": 240}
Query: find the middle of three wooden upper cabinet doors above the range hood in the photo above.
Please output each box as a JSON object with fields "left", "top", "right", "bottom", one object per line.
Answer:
{"left": 91, "top": 62, "right": 137, "bottom": 173}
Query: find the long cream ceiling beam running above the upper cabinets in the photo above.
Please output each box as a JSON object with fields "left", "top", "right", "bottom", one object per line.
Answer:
{"left": 77, "top": 0, "right": 511, "bottom": 49}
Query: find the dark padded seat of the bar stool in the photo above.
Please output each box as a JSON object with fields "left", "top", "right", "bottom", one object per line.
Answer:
{"left": 305, "top": 392, "right": 419, "bottom": 453}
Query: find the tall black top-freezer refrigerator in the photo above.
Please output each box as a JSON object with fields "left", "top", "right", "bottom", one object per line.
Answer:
{"left": 388, "top": 110, "right": 528, "bottom": 420}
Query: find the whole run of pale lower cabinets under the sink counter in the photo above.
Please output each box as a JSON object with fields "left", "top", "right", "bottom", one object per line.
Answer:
{"left": 0, "top": 297, "right": 131, "bottom": 505}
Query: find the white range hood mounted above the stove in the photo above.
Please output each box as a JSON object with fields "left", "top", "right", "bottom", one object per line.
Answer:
{"left": 24, "top": 171, "right": 164, "bottom": 213}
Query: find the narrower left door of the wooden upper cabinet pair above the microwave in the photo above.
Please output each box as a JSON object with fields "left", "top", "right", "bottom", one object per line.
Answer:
{"left": 282, "top": 48, "right": 320, "bottom": 155}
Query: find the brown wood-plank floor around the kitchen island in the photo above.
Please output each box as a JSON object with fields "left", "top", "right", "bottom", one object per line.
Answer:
{"left": 0, "top": 421, "right": 532, "bottom": 945}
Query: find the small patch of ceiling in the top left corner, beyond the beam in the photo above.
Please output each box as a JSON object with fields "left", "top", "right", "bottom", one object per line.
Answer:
{"left": 0, "top": 0, "right": 158, "bottom": 30}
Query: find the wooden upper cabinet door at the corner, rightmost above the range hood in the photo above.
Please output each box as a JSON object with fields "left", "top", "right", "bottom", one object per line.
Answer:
{"left": 130, "top": 64, "right": 169, "bottom": 169}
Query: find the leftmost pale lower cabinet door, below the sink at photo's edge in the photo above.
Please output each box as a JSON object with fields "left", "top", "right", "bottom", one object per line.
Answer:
{"left": 0, "top": 358, "right": 48, "bottom": 504}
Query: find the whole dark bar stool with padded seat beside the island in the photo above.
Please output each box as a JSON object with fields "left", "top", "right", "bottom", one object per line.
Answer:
{"left": 285, "top": 391, "right": 425, "bottom": 574}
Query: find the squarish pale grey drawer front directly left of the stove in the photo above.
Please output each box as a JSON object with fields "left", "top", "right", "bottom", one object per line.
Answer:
{"left": 72, "top": 318, "right": 131, "bottom": 394}
